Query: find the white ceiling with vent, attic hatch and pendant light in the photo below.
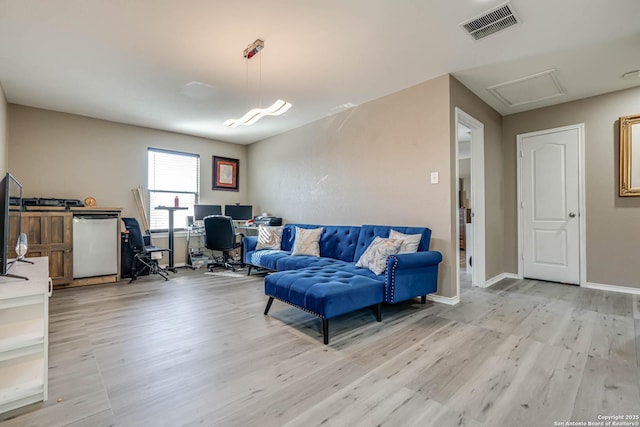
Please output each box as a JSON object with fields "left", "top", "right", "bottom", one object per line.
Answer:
{"left": 0, "top": 0, "right": 640, "bottom": 144}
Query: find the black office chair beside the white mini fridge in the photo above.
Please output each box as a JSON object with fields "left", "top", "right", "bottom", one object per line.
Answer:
{"left": 122, "top": 218, "right": 169, "bottom": 283}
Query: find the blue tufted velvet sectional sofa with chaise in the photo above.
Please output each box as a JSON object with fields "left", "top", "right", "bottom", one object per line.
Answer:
{"left": 243, "top": 224, "right": 442, "bottom": 344}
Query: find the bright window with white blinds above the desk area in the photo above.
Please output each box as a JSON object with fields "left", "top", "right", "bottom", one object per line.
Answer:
{"left": 147, "top": 148, "right": 200, "bottom": 231}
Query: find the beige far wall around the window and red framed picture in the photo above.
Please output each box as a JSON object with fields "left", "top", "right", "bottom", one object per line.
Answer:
{"left": 8, "top": 104, "right": 250, "bottom": 263}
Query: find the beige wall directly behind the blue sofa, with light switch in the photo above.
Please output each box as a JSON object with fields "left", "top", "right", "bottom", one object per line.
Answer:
{"left": 248, "top": 76, "right": 455, "bottom": 296}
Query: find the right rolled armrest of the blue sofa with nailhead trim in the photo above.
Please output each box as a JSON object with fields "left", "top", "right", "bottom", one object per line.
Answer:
{"left": 385, "top": 251, "right": 442, "bottom": 303}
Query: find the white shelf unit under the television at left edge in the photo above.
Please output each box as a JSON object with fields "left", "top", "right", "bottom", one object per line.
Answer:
{"left": 0, "top": 257, "right": 52, "bottom": 413}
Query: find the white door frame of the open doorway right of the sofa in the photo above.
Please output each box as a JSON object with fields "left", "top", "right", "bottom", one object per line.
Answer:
{"left": 454, "top": 107, "right": 487, "bottom": 296}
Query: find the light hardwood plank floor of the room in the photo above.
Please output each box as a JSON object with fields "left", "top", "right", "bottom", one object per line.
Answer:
{"left": 0, "top": 270, "right": 640, "bottom": 427}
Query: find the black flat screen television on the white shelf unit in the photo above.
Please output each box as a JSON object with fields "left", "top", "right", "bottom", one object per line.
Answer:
{"left": 0, "top": 173, "right": 26, "bottom": 279}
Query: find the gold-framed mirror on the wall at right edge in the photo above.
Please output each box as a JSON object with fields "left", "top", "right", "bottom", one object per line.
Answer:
{"left": 620, "top": 114, "right": 640, "bottom": 197}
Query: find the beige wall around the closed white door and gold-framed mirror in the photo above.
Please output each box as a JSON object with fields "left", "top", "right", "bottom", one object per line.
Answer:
{"left": 503, "top": 88, "right": 640, "bottom": 288}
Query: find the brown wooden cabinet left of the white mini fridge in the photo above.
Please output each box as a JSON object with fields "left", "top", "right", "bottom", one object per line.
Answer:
{"left": 9, "top": 211, "right": 73, "bottom": 285}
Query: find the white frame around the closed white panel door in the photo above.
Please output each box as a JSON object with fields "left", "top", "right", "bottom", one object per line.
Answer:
{"left": 516, "top": 123, "right": 587, "bottom": 286}
